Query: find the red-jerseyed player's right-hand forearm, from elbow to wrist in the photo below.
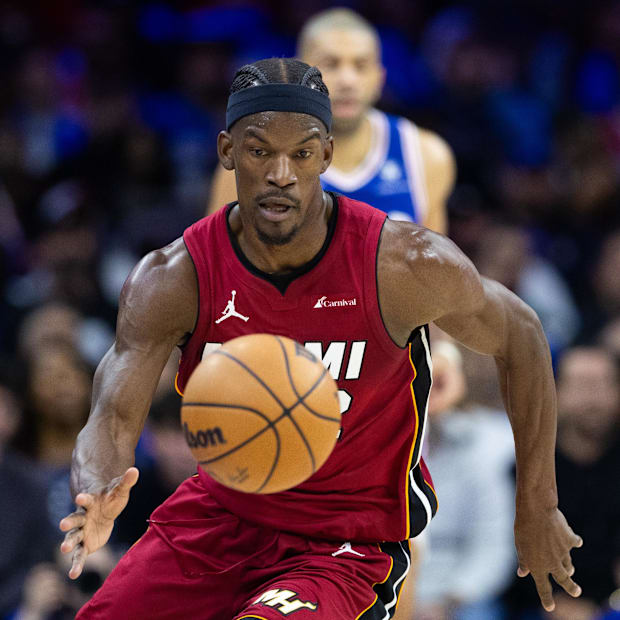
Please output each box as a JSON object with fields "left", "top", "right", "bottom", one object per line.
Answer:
{"left": 496, "top": 308, "right": 557, "bottom": 508}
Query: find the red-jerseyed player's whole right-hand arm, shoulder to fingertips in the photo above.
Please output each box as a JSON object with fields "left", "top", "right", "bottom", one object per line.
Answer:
{"left": 378, "top": 222, "right": 581, "bottom": 610}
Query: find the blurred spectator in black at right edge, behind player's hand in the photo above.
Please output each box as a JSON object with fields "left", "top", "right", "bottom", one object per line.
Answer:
{"left": 510, "top": 347, "right": 620, "bottom": 620}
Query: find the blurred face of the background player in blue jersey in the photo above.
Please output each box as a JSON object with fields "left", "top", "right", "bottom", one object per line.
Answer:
{"left": 303, "top": 29, "right": 385, "bottom": 131}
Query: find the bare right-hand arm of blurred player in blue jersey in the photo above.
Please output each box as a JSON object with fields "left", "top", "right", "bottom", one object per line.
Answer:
{"left": 419, "top": 129, "right": 456, "bottom": 235}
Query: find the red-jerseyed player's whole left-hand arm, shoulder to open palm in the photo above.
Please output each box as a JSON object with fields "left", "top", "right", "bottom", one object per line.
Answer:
{"left": 60, "top": 240, "right": 197, "bottom": 578}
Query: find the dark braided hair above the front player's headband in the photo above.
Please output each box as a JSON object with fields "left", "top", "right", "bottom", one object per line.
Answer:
{"left": 230, "top": 58, "right": 329, "bottom": 95}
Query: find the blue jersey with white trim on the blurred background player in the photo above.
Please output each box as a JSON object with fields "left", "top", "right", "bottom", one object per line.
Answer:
{"left": 321, "top": 109, "right": 428, "bottom": 223}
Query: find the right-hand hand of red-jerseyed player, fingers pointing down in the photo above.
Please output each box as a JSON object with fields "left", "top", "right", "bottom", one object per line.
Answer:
{"left": 515, "top": 508, "right": 583, "bottom": 611}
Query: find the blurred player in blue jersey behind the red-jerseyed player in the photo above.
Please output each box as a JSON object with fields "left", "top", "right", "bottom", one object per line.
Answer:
{"left": 208, "top": 8, "right": 455, "bottom": 234}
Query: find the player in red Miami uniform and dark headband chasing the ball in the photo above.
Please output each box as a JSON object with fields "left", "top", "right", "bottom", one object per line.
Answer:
{"left": 60, "top": 59, "right": 581, "bottom": 620}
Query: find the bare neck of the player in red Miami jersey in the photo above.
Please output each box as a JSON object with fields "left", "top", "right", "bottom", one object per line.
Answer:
{"left": 229, "top": 190, "right": 333, "bottom": 273}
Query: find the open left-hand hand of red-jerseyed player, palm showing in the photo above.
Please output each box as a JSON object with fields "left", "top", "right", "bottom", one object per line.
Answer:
{"left": 60, "top": 467, "right": 139, "bottom": 579}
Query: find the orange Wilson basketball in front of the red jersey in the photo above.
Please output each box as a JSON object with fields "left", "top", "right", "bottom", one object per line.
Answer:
{"left": 181, "top": 334, "right": 340, "bottom": 493}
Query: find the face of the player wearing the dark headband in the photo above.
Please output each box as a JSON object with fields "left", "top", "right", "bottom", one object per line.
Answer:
{"left": 218, "top": 112, "right": 332, "bottom": 245}
